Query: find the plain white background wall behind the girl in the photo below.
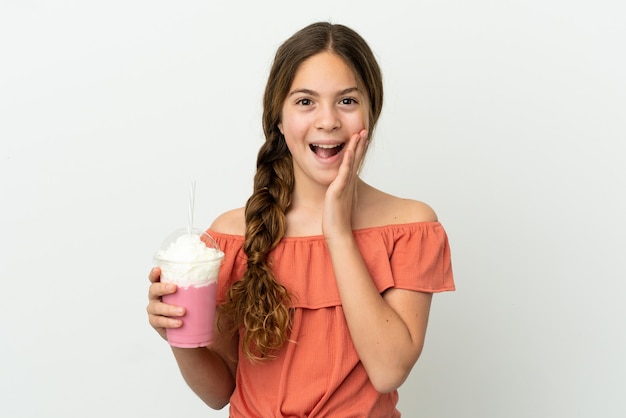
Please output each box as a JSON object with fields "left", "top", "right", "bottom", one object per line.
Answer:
{"left": 0, "top": 0, "right": 626, "bottom": 418}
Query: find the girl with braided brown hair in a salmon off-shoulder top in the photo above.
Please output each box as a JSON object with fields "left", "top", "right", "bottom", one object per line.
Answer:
{"left": 147, "top": 23, "right": 454, "bottom": 418}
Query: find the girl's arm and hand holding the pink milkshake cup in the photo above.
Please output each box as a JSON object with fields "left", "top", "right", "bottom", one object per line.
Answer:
{"left": 147, "top": 268, "right": 237, "bottom": 409}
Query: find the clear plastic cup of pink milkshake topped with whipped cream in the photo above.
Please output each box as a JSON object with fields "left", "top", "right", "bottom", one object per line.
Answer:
{"left": 154, "top": 228, "right": 224, "bottom": 348}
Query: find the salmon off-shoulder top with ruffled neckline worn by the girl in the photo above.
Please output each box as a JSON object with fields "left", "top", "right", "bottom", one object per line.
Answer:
{"left": 208, "top": 222, "right": 454, "bottom": 418}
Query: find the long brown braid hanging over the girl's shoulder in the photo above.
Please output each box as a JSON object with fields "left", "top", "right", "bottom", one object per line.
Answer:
{"left": 222, "top": 134, "right": 294, "bottom": 360}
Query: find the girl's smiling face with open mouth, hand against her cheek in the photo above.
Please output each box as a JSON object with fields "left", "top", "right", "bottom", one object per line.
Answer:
{"left": 278, "top": 52, "right": 368, "bottom": 186}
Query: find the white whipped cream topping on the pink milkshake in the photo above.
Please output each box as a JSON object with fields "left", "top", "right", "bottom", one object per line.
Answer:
{"left": 154, "top": 233, "right": 224, "bottom": 287}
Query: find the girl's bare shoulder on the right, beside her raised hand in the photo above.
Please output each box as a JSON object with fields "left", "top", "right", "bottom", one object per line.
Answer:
{"left": 359, "top": 182, "right": 438, "bottom": 227}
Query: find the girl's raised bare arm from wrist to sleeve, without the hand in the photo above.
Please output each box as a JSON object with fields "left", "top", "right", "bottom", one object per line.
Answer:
{"left": 328, "top": 236, "right": 432, "bottom": 393}
